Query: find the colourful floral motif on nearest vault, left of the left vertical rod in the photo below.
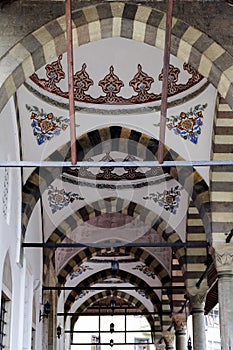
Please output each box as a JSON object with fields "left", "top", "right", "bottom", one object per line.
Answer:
{"left": 26, "top": 105, "right": 70, "bottom": 145}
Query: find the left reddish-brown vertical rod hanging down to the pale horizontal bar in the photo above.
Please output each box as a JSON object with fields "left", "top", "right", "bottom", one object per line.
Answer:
{"left": 66, "top": 0, "right": 77, "bottom": 165}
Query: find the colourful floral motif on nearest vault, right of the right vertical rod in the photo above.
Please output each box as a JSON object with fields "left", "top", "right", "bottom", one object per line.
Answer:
{"left": 166, "top": 103, "right": 207, "bottom": 144}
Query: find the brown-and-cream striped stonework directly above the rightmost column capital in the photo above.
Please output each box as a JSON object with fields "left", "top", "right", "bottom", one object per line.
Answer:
{"left": 210, "top": 98, "right": 233, "bottom": 242}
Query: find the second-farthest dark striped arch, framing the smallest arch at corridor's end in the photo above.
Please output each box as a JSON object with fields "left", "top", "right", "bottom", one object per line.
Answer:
{"left": 64, "top": 269, "right": 161, "bottom": 313}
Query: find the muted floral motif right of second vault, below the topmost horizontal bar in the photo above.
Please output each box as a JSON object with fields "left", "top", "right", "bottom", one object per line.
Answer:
{"left": 143, "top": 186, "right": 182, "bottom": 214}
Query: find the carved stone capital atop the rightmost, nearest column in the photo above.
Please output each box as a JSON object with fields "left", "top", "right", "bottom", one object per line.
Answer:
{"left": 211, "top": 243, "right": 233, "bottom": 274}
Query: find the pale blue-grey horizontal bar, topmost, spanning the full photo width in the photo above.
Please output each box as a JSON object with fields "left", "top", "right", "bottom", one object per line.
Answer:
{"left": 0, "top": 160, "right": 233, "bottom": 168}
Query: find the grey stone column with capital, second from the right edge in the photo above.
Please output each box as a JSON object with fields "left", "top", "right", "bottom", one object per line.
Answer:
{"left": 188, "top": 281, "right": 208, "bottom": 350}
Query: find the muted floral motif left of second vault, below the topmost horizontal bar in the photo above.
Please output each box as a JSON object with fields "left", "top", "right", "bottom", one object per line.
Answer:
{"left": 48, "top": 185, "right": 85, "bottom": 214}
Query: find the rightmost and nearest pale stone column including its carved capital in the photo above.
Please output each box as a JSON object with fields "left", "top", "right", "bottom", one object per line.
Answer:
{"left": 214, "top": 243, "right": 233, "bottom": 350}
